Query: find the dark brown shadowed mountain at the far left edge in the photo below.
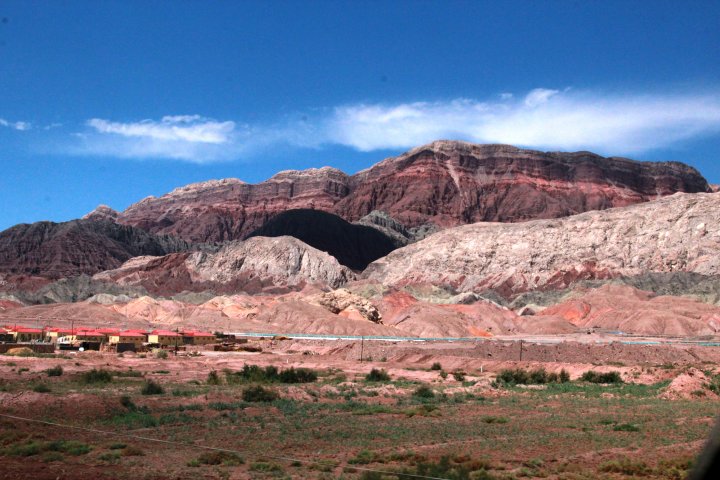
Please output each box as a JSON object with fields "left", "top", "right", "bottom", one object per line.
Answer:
{"left": 0, "top": 220, "right": 190, "bottom": 279}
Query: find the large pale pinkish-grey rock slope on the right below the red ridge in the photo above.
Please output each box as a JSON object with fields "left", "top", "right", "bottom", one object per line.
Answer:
{"left": 363, "top": 193, "right": 720, "bottom": 298}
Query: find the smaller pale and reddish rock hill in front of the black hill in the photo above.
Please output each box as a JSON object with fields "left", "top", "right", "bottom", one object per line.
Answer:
{"left": 94, "top": 237, "right": 354, "bottom": 295}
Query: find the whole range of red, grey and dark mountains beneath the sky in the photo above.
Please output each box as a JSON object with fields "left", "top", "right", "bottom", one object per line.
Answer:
{"left": 0, "top": 141, "right": 720, "bottom": 336}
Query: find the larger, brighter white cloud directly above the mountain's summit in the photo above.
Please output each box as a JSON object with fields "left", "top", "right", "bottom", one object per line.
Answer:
{"left": 324, "top": 89, "right": 720, "bottom": 154}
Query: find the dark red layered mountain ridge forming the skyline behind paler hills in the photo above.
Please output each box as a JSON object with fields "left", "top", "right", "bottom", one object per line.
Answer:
{"left": 112, "top": 141, "right": 710, "bottom": 242}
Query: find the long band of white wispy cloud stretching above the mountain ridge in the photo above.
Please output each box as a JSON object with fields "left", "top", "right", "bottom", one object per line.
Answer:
{"left": 67, "top": 88, "right": 720, "bottom": 163}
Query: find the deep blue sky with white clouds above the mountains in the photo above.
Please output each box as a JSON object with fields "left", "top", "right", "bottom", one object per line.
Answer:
{"left": 0, "top": 0, "right": 720, "bottom": 230}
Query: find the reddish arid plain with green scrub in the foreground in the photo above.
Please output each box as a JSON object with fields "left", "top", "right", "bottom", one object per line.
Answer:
{"left": 0, "top": 340, "right": 720, "bottom": 479}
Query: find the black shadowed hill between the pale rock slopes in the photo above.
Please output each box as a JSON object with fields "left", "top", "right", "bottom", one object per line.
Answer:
{"left": 250, "top": 209, "right": 396, "bottom": 270}
